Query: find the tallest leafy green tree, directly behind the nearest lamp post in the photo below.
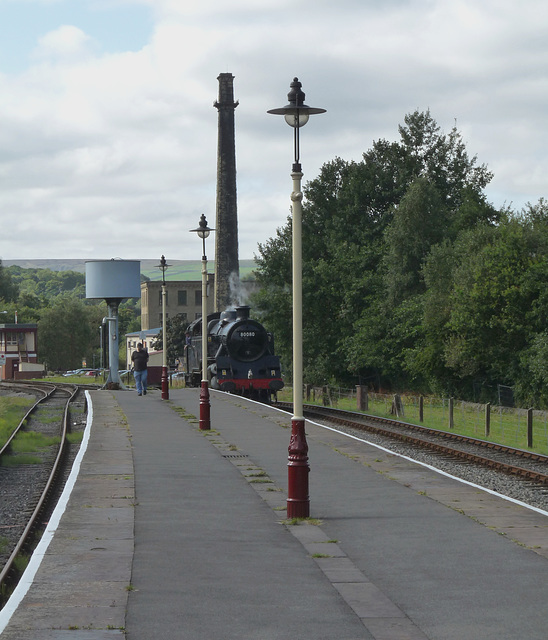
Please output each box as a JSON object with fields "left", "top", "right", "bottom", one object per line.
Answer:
{"left": 256, "top": 111, "right": 496, "bottom": 383}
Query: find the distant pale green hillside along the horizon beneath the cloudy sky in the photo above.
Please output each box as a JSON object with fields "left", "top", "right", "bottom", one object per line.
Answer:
{"left": 2, "top": 259, "right": 255, "bottom": 280}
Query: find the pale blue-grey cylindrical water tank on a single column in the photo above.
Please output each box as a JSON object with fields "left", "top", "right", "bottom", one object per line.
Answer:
{"left": 86, "top": 259, "right": 141, "bottom": 387}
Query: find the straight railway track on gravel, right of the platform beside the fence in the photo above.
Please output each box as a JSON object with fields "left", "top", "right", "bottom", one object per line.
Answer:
{"left": 275, "top": 402, "right": 548, "bottom": 488}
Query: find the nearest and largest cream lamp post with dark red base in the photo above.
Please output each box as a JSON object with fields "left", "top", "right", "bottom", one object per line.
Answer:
{"left": 268, "top": 78, "right": 325, "bottom": 518}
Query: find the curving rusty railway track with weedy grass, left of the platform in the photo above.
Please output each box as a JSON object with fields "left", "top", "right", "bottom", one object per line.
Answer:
{"left": 0, "top": 382, "right": 86, "bottom": 607}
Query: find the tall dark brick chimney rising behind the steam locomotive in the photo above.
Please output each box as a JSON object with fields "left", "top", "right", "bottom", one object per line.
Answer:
{"left": 214, "top": 73, "right": 240, "bottom": 311}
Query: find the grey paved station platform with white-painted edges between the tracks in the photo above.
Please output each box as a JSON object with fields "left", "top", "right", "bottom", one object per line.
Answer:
{"left": 0, "top": 389, "right": 548, "bottom": 640}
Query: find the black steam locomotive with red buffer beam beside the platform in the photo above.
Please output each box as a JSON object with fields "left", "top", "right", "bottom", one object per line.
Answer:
{"left": 184, "top": 306, "right": 284, "bottom": 402}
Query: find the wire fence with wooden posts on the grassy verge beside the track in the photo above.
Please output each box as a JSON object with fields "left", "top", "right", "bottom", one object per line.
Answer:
{"left": 278, "top": 385, "right": 548, "bottom": 455}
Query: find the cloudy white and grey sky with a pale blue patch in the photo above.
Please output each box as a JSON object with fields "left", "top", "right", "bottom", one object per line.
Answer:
{"left": 0, "top": 0, "right": 548, "bottom": 261}
